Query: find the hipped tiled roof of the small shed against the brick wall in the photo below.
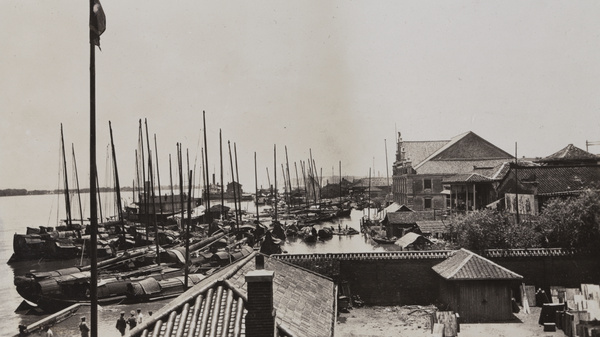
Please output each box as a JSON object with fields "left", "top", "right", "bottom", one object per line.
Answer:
{"left": 432, "top": 248, "right": 523, "bottom": 281}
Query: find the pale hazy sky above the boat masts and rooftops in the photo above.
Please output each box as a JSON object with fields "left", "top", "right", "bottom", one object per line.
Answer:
{"left": 0, "top": 0, "right": 600, "bottom": 191}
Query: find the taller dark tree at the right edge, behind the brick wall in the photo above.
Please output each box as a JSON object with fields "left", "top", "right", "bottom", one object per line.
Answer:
{"left": 539, "top": 189, "right": 600, "bottom": 248}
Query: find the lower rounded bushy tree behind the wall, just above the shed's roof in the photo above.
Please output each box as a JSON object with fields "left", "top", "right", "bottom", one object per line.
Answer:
{"left": 450, "top": 209, "right": 541, "bottom": 251}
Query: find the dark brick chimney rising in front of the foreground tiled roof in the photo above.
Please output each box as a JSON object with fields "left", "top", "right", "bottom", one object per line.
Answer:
{"left": 246, "top": 269, "right": 277, "bottom": 337}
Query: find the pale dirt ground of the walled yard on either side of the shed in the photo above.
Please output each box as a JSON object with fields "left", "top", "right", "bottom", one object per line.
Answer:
{"left": 335, "top": 306, "right": 564, "bottom": 337}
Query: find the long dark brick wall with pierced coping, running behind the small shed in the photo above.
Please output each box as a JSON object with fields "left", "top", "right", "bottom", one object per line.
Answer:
{"left": 273, "top": 249, "right": 600, "bottom": 305}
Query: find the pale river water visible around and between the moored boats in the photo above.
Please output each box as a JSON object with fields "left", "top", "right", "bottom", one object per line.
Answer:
{"left": 0, "top": 193, "right": 399, "bottom": 336}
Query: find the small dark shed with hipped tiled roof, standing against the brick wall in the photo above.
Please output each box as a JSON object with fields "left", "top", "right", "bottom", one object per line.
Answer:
{"left": 433, "top": 248, "right": 523, "bottom": 323}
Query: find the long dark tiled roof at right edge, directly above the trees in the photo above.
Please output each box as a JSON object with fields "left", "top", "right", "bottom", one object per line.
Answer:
{"left": 517, "top": 165, "right": 600, "bottom": 195}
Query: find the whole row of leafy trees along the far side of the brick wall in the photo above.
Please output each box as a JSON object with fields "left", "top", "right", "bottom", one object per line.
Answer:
{"left": 450, "top": 189, "right": 600, "bottom": 251}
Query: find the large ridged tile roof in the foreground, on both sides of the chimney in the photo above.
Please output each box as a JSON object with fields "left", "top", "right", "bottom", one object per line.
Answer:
{"left": 131, "top": 253, "right": 336, "bottom": 337}
